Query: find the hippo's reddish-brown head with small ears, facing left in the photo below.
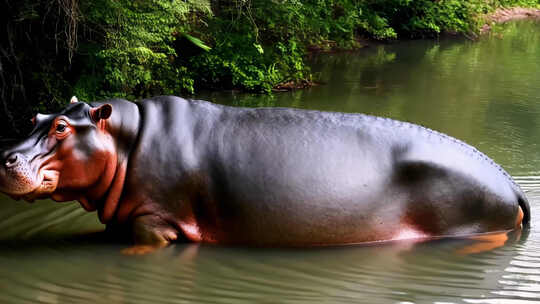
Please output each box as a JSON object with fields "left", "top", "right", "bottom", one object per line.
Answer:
{"left": 0, "top": 99, "right": 118, "bottom": 211}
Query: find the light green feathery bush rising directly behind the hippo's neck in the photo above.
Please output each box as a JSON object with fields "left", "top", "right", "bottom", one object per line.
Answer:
{"left": 75, "top": 0, "right": 209, "bottom": 99}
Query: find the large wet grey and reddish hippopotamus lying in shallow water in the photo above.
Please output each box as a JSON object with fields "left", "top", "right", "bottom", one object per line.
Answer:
{"left": 0, "top": 96, "right": 530, "bottom": 247}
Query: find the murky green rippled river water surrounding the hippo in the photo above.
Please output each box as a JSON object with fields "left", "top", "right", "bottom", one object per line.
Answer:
{"left": 0, "top": 21, "right": 540, "bottom": 303}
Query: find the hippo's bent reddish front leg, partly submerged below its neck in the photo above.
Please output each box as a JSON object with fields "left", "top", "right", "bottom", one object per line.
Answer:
{"left": 122, "top": 214, "right": 178, "bottom": 254}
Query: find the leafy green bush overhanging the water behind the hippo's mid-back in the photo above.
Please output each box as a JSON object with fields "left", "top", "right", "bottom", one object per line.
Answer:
{"left": 187, "top": 1, "right": 308, "bottom": 92}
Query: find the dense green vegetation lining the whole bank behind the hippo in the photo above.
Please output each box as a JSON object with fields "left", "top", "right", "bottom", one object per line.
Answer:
{"left": 0, "top": 0, "right": 540, "bottom": 135}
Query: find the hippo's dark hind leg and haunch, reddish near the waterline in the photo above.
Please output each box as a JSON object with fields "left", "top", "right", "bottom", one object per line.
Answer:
{"left": 392, "top": 161, "right": 519, "bottom": 237}
